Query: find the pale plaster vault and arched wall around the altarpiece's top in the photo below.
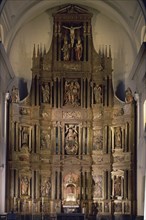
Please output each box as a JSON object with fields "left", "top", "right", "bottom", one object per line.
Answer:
{"left": 0, "top": 0, "right": 146, "bottom": 98}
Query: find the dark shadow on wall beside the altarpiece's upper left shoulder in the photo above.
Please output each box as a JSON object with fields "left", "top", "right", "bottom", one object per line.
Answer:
{"left": 19, "top": 78, "right": 28, "bottom": 100}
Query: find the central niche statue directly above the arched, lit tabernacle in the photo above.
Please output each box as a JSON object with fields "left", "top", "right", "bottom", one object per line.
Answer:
{"left": 65, "top": 125, "right": 78, "bottom": 155}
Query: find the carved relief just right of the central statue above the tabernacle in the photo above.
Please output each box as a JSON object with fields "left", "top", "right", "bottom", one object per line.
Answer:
{"left": 93, "top": 129, "right": 103, "bottom": 150}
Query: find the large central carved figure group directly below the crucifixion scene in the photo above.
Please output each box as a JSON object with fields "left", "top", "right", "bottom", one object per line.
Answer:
{"left": 64, "top": 80, "right": 80, "bottom": 106}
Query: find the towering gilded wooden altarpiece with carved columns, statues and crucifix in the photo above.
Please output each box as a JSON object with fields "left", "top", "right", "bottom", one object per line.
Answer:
{"left": 7, "top": 5, "right": 136, "bottom": 215}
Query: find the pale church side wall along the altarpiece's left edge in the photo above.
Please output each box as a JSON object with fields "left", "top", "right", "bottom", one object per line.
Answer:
{"left": 0, "top": 42, "right": 14, "bottom": 213}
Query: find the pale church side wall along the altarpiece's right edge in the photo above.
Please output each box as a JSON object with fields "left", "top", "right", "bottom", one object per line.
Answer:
{"left": 130, "top": 42, "right": 146, "bottom": 216}
